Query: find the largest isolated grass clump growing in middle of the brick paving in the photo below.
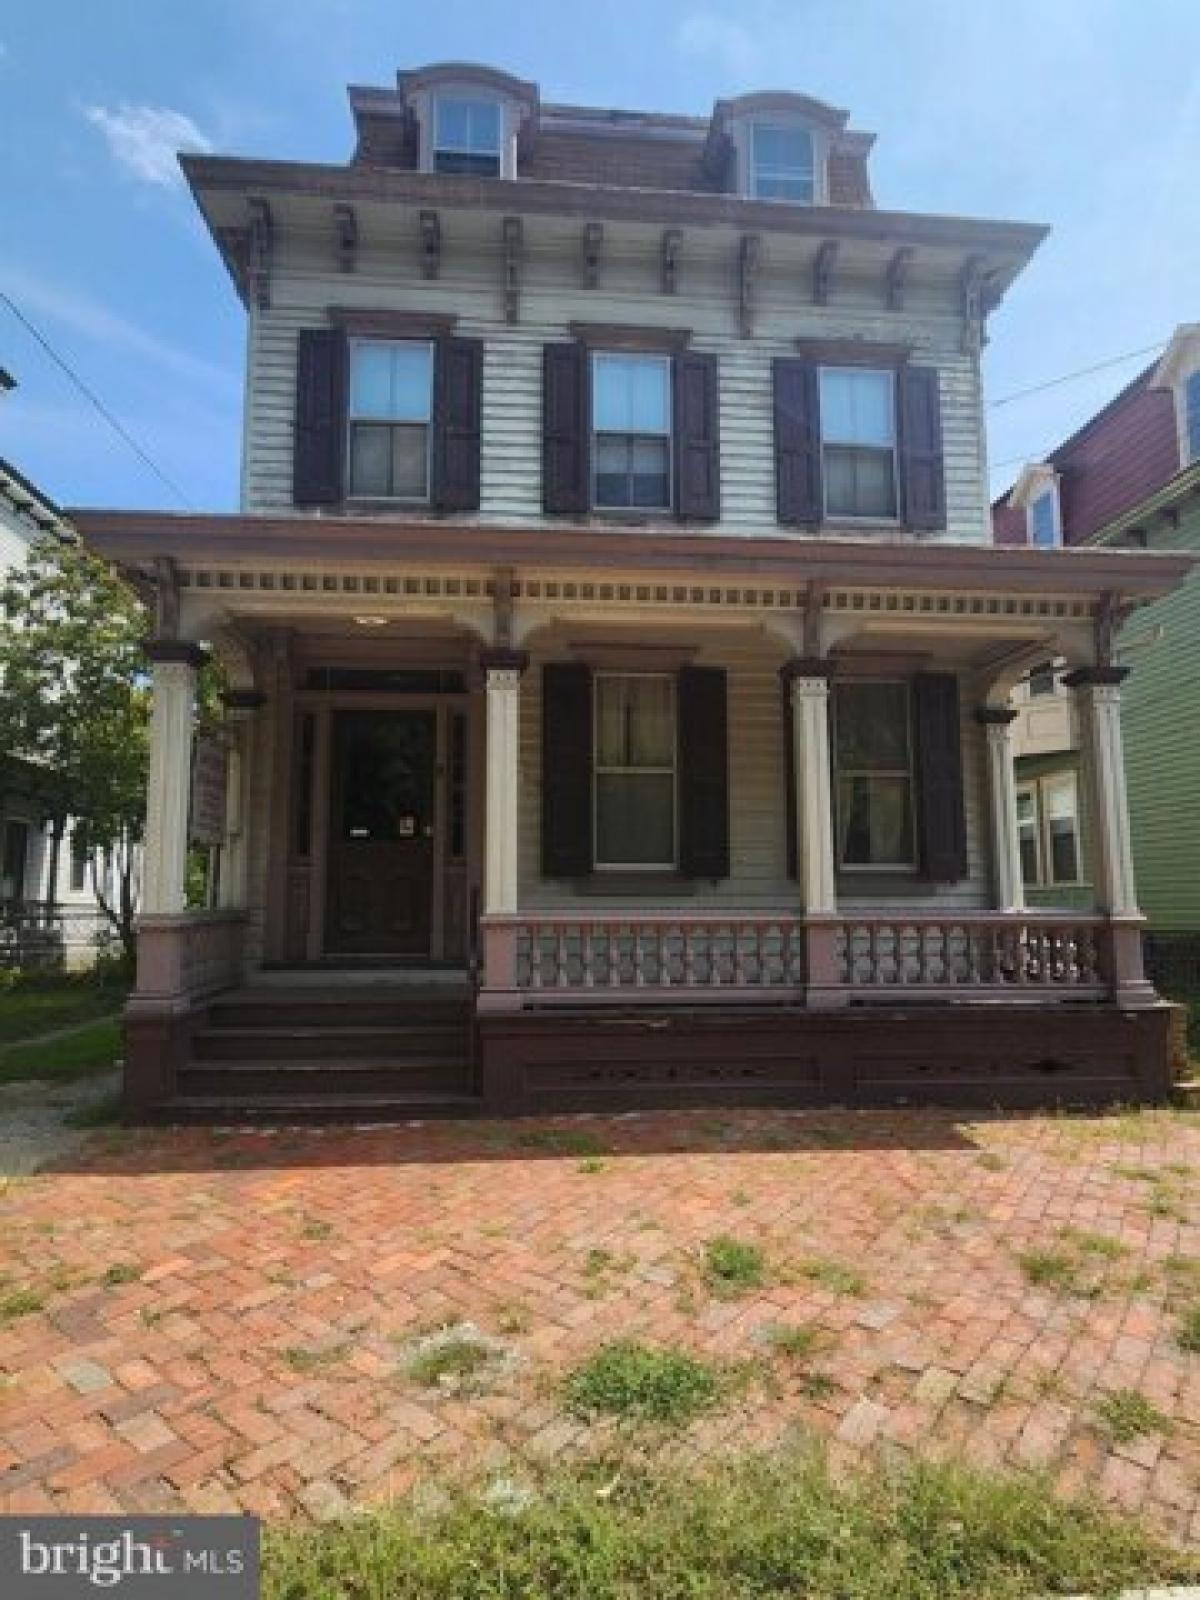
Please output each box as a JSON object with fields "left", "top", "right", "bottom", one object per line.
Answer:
{"left": 565, "top": 1339, "right": 722, "bottom": 1427}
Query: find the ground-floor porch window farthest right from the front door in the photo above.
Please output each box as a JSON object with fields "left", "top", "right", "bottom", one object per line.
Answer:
{"left": 834, "top": 680, "right": 917, "bottom": 869}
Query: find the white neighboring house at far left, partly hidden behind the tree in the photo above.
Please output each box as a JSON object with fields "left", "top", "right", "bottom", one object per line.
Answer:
{"left": 0, "top": 459, "right": 112, "bottom": 966}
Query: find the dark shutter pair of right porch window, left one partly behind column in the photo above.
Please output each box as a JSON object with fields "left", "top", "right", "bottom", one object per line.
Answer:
{"left": 781, "top": 672, "right": 968, "bottom": 883}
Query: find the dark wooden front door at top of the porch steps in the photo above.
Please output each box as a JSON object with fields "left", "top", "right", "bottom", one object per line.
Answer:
{"left": 325, "top": 710, "right": 437, "bottom": 957}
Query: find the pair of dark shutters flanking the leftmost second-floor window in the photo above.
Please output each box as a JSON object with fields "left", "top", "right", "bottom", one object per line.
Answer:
{"left": 293, "top": 328, "right": 483, "bottom": 510}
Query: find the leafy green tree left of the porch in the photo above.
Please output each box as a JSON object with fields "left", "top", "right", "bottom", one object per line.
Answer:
{"left": 0, "top": 534, "right": 150, "bottom": 960}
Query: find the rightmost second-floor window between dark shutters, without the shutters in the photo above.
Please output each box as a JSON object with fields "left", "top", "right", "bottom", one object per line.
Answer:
{"left": 821, "top": 366, "right": 896, "bottom": 520}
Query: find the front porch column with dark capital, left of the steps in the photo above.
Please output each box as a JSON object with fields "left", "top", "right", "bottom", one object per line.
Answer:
{"left": 141, "top": 638, "right": 203, "bottom": 917}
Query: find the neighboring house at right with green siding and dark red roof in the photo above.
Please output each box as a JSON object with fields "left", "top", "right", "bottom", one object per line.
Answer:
{"left": 994, "top": 323, "right": 1200, "bottom": 965}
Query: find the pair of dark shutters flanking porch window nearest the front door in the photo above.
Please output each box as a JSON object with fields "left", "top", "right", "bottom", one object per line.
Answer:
{"left": 542, "top": 661, "right": 730, "bottom": 878}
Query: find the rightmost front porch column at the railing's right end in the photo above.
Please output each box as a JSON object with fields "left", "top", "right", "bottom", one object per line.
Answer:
{"left": 1064, "top": 666, "right": 1155, "bottom": 1005}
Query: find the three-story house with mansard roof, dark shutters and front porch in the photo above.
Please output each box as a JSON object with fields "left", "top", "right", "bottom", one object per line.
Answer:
{"left": 72, "top": 62, "right": 1190, "bottom": 1117}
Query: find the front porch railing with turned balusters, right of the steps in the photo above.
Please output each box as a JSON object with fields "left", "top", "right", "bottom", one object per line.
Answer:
{"left": 482, "top": 910, "right": 1112, "bottom": 1005}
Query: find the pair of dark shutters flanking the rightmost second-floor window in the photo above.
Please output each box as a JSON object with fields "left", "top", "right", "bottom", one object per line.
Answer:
{"left": 771, "top": 357, "right": 946, "bottom": 533}
